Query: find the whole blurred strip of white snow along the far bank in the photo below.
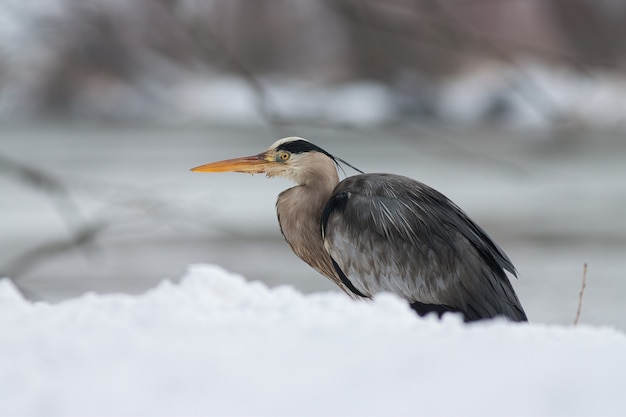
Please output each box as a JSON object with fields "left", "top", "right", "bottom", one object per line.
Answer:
{"left": 89, "top": 62, "right": 626, "bottom": 130}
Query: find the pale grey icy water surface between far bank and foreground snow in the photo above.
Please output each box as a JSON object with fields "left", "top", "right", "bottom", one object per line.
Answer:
{"left": 0, "top": 124, "right": 626, "bottom": 329}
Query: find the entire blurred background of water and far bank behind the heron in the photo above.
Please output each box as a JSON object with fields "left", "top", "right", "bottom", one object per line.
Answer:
{"left": 0, "top": 0, "right": 626, "bottom": 330}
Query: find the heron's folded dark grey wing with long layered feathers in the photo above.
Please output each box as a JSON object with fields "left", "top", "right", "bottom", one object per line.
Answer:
{"left": 322, "top": 174, "right": 526, "bottom": 321}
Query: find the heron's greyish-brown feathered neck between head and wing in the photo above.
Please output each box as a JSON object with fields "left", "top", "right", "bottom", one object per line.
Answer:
{"left": 276, "top": 156, "right": 340, "bottom": 282}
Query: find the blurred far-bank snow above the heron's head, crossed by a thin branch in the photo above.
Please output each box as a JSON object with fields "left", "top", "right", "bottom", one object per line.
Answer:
{"left": 156, "top": 73, "right": 395, "bottom": 127}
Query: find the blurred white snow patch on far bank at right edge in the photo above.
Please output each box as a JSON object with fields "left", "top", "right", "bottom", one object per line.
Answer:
{"left": 439, "top": 61, "right": 626, "bottom": 129}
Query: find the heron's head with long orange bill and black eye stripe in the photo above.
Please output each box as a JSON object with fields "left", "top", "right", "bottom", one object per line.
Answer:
{"left": 192, "top": 137, "right": 346, "bottom": 184}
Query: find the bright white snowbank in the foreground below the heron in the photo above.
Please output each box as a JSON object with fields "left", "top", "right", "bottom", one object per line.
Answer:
{"left": 0, "top": 265, "right": 626, "bottom": 416}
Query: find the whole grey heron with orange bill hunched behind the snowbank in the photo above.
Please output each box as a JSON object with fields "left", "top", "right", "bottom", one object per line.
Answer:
{"left": 192, "top": 137, "right": 527, "bottom": 322}
